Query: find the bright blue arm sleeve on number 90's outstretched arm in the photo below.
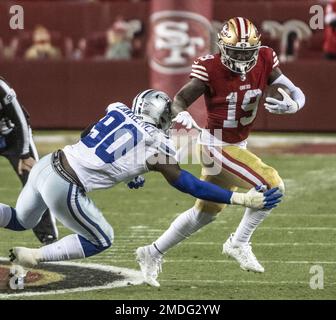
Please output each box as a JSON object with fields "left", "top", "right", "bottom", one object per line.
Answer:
{"left": 171, "top": 170, "right": 232, "bottom": 204}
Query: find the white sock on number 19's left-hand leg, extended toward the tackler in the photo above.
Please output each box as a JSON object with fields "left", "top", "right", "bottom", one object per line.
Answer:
{"left": 150, "top": 207, "right": 216, "bottom": 257}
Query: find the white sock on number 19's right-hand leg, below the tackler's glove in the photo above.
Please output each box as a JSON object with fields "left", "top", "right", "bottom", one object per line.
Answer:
{"left": 232, "top": 208, "right": 272, "bottom": 246}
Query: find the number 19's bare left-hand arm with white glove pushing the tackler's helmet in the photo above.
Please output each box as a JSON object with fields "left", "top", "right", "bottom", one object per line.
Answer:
{"left": 172, "top": 78, "right": 207, "bottom": 129}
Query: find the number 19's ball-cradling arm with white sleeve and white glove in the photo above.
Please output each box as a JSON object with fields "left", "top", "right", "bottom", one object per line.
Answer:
{"left": 265, "top": 67, "right": 306, "bottom": 114}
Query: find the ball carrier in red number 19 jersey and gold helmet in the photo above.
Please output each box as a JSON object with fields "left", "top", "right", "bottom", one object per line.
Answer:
{"left": 135, "top": 17, "right": 305, "bottom": 286}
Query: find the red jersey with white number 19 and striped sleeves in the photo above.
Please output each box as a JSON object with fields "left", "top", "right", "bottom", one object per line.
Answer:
{"left": 190, "top": 47, "right": 279, "bottom": 143}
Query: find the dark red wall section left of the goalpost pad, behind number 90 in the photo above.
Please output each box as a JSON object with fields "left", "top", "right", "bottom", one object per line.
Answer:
{"left": 0, "top": 59, "right": 148, "bottom": 129}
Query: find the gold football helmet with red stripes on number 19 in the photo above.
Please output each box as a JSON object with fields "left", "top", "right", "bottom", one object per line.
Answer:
{"left": 217, "top": 17, "right": 260, "bottom": 79}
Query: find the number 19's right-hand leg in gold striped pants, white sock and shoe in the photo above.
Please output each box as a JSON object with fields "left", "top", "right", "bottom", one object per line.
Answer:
{"left": 211, "top": 146, "right": 284, "bottom": 272}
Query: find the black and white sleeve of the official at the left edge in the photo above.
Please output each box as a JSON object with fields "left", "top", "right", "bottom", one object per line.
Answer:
{"left": 0, "top": 79, "right": 30, "bottom": 158}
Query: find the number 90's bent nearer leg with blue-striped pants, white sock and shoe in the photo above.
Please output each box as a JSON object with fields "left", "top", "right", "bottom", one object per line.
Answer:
{"left": 12, "top": 168, "right": 113, "bottom": 266}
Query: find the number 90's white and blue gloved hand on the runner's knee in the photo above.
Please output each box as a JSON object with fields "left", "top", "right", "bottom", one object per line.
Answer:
{"left": 231, "top": 187, "right": 282, "bottom": 209}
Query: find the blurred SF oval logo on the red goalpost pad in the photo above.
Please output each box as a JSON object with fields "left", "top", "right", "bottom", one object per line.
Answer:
{"left": 149, "top": 11, "right": 211, "bottom": 74}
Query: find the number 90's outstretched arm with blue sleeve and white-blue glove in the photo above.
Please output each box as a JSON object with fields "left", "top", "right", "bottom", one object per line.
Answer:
{"left": 147, "top": 154, "right": 282, "bottom": 209}
